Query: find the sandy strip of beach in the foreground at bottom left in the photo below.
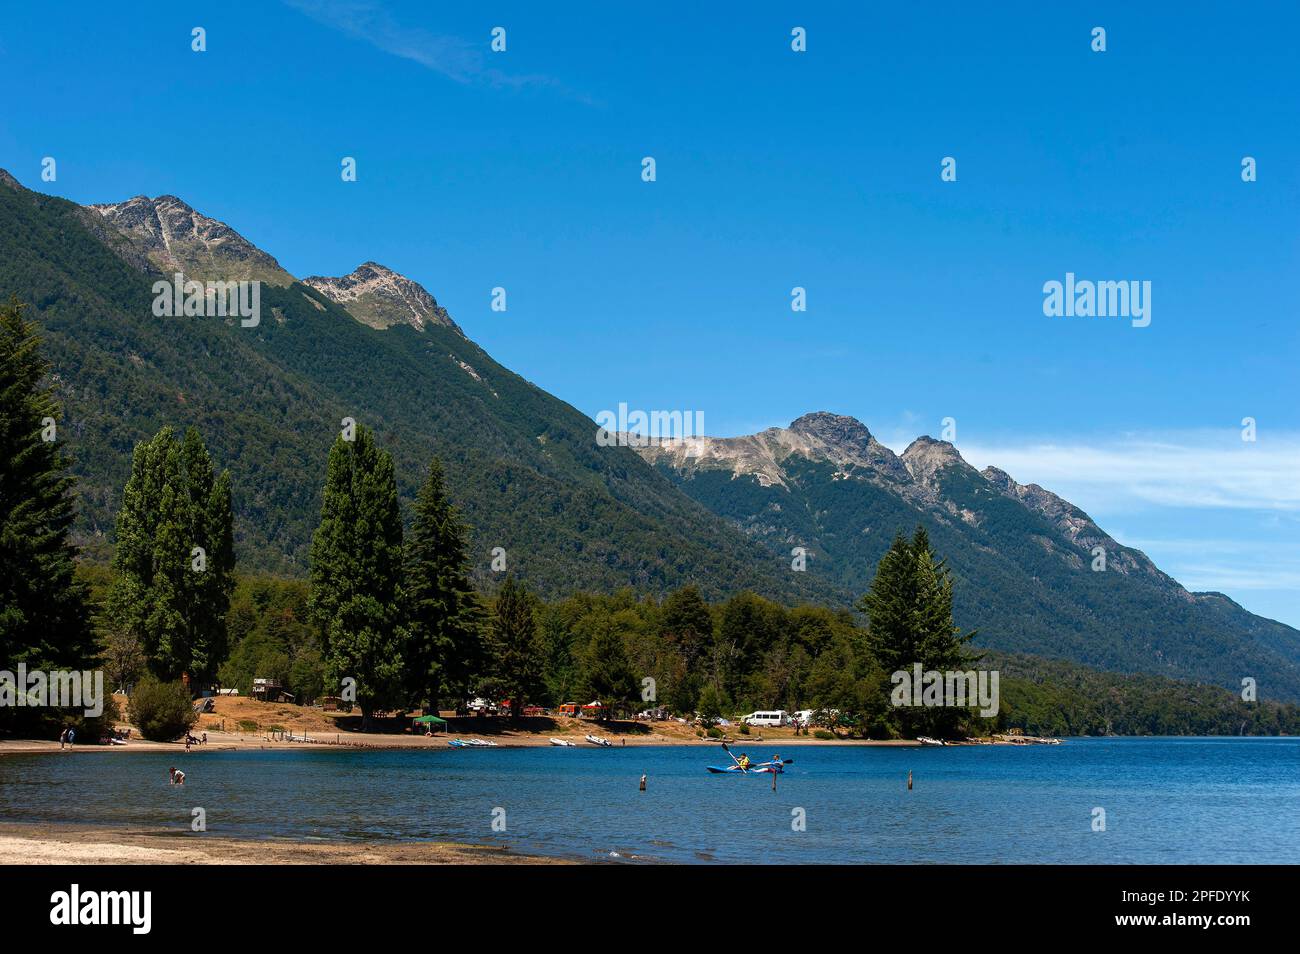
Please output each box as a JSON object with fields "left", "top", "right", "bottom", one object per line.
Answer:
{"left": 0, "top": 821, "right": 574, "bottom": 866}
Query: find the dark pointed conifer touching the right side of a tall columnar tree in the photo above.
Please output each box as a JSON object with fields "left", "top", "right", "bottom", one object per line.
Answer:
{"left": 406, "top": 458, "right": 484, "bottom": 710}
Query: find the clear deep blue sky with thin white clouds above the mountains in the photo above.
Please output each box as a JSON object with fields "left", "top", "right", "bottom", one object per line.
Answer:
{"left": 0, "top": 0, "right": 1300, "bottom": 625}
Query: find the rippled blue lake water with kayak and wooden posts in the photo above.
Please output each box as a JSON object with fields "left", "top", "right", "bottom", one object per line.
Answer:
{"left": 0, "top": 738, "right": 1300, "bottom": 864}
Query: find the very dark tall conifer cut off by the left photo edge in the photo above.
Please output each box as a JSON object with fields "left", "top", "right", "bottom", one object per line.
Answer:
{"left": 0, "top": 299, "right": 94, "bottom": 668}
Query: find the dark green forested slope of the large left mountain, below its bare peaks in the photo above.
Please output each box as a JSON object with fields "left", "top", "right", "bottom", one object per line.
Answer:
{"left": 0, "top": 175, "right": 831, "bottom": 599}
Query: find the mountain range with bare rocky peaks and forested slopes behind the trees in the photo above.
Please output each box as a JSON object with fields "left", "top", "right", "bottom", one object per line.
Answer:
{"left": 0, "top": 170, "right": 1300, "bottom": 701}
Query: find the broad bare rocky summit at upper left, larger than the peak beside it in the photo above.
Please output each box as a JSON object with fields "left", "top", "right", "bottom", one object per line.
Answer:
{"left": 87, "top": 195, "right": 294, "bottom": 286}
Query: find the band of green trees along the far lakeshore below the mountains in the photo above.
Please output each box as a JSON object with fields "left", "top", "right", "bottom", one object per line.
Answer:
{"left": 0, "top": 287, "right": 1300, "bottom": 738}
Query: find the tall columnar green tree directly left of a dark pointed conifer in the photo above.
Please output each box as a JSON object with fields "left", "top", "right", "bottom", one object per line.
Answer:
{"left": 308, "top": 425, "right": 406, "bottom": 729}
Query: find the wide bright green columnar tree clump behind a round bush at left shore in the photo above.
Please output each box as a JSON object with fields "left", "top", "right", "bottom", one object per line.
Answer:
{"left": 108, "top": 428, "right": 235, "bottom": 685}
